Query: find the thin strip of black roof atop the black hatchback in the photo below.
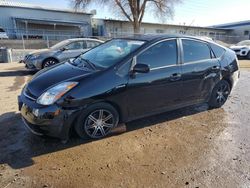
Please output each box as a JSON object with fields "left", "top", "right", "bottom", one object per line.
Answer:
{"left": 118, "top": 34, "right": 211, "bottom": 42}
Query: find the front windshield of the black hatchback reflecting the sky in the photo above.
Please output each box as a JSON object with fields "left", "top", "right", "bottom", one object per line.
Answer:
{"left": 71, "top": 39, "right": 144, "bottom": 68}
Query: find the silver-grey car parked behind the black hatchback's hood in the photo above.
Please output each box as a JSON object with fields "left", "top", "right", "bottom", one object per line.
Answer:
{"left": 20, "top": 38, "right": 103, "bottom": 70}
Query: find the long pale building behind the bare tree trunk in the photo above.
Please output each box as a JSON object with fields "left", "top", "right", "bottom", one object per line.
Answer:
{"left": 92, "top": 19, "right": 231, "bottom": 38}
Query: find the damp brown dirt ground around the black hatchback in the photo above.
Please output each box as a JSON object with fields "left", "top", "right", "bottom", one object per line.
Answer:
{"left": 0, "top": 61, "right": 250, "bottom": 188}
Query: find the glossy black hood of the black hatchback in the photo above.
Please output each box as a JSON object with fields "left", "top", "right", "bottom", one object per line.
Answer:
{"left": 26, "top": 62, "right": 96, "bottom": 97}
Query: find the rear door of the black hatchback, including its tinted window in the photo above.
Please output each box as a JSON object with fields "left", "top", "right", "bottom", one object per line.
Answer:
{"left": 180, "top": 39, "right": 221, "bottom": 104}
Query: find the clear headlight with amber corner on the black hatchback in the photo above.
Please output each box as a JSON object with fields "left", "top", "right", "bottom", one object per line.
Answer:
{"left": 37, "top": 82, "right": 78, "bottom": 105}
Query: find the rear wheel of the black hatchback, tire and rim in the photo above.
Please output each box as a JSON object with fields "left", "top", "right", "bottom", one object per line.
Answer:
{"left": 208, "top": 80, "right": 231, "bottom": 108}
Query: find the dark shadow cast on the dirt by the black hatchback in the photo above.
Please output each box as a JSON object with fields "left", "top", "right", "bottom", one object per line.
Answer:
{"left": 0, "top": 104, "right": 208, "bottom": 169}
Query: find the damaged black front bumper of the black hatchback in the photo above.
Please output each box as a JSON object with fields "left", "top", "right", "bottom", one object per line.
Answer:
{"left": 18, "top": 94, "right": 79, "bottom": 140}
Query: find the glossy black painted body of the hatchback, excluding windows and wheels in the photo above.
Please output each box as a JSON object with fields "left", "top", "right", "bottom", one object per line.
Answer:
{"left": 19, "top": 36, "right": 239, "bottom": 139}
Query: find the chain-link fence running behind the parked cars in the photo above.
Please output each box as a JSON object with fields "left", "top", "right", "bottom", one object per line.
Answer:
{"left": 0, "top": 30, "right": 247, "bottom": 62}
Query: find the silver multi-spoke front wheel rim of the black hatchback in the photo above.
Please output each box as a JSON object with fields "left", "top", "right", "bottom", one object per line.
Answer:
{"left": 84, "top": 109, "right": 115, "bottom": 138}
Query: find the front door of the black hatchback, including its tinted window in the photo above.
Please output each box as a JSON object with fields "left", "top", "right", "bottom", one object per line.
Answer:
{"left": 127, "top": 39, "right": 181, "bottom": 117}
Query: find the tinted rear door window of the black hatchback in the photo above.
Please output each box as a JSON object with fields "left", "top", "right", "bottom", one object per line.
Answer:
{"left": 182, "top": 39, "right": 211, "bottom": 63}
